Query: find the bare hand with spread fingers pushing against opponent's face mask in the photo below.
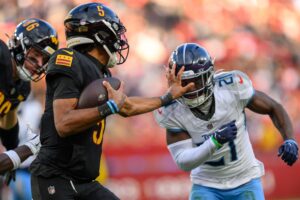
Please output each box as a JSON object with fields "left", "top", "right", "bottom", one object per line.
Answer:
{"left": 166, "top": 64, "right": 194, "bottom": 99}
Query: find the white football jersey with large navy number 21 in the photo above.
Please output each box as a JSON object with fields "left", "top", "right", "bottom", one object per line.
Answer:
{"left": 154, "top": 71, "right": 264, "bottom": 189}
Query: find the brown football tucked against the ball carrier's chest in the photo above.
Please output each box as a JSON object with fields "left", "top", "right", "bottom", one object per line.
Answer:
{"left": 77, "top": 77, "right": 121, "bottom": 108}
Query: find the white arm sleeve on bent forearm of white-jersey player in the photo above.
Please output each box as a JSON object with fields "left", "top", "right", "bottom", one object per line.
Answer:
{"left": 168, "top": 138, "right": 217, "bottom": 171}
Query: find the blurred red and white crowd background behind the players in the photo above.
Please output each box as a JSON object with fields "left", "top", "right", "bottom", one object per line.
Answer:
{"left": 0, "top": 0, "right": 300, "bottom": 199}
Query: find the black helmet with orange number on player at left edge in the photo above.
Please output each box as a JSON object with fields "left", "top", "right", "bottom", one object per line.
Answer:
{"left": 8, "top": 18, "right": 58, "bottom": 81}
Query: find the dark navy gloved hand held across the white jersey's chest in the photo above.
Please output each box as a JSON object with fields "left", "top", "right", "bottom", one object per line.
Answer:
{"left": 213, "top": 120, "right": 237, "bottom": 145}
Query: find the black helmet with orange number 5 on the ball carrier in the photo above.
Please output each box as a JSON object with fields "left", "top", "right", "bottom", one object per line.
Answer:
{"left": 64, "top": 3, "right": 129, "bottom": 67}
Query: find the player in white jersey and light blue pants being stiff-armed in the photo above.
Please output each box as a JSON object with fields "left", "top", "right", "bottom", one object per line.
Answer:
{"left": 154, "top": 43, "right": 298, "bottom": 200}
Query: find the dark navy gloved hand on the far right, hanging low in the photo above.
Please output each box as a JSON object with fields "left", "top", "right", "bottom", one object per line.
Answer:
{"left": 278, "top": 139, "right": 298, "bottom": 166}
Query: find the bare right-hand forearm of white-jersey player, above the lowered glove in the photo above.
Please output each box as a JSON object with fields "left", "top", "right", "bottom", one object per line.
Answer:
{"left": 270, "top": 104, "right": 294, "bottom": 140}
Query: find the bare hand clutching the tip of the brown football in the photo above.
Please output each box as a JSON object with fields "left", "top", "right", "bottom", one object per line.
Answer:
{"left": 103, "top": 81, "right": 127, "bottom": 110}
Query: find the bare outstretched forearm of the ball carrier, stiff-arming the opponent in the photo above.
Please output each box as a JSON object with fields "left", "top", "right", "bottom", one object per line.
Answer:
{"left": 120, "top": 97, "right": 162, "bottom": 117}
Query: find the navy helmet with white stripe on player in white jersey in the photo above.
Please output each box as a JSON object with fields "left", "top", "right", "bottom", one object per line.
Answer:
{"left": 169, "top": 43, "right": 214, "bottom": 108}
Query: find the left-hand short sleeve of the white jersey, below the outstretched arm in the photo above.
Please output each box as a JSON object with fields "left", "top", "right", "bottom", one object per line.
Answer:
{"left": 153, "top": 105, "right": 186, "bottom": 133}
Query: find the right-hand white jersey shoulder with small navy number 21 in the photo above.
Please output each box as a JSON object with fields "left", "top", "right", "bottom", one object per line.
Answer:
{"left": 215, "top": 70, "right": 254, "bottom": 100}
